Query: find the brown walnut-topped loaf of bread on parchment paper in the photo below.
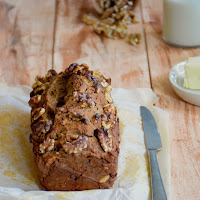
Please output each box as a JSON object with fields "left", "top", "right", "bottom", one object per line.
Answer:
{"left": 29, "top": 63, "right": 119, "bottom": 191}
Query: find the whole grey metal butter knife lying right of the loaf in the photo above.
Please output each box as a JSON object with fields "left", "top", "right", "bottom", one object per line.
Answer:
{"left": 140, "top": 106, "right": 167, "bottom": 200}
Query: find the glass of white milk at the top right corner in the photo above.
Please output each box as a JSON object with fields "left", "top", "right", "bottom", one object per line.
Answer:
{"left": 162, "top": 0, "right": 200, "bottom": 47}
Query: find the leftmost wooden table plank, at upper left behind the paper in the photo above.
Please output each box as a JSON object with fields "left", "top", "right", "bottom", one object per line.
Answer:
{"left": 0, "top": 0, "right": 55, "bottom": 85}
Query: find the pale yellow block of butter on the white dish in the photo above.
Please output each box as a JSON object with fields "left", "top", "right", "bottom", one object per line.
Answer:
{"left": 184, "top": 57, "right": 200, "bottom": 90}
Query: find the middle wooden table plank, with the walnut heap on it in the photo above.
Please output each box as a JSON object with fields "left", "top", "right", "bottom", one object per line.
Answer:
{"left": 54, "top": 0, "right": 150, "bottom": 88}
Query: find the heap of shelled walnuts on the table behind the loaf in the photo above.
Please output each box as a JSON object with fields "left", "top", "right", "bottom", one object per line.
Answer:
{"left": 83, "top": 0, "right": 141, "bottom": 44}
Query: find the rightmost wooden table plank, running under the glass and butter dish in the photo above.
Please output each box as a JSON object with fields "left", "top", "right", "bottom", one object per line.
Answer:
{"left": 142, "top": 0, "right": 200, "bottom": 200}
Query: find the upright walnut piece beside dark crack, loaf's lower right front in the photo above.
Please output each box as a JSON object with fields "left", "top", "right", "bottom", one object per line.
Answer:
{"left": 97, "top": 128, "right": 112, "bottom": 152}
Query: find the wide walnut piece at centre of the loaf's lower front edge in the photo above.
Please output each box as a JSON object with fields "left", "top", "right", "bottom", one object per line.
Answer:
{"left": 63, "top": 136, "right": 88, "bottom": 154}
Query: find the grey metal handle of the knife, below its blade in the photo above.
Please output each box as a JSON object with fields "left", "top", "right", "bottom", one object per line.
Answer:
{"left": 149, "top": 150, "right": 167, "bottom": 200}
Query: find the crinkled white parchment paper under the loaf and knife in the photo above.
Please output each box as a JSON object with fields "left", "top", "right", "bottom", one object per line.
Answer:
{"left": 0, "top": 84, "right": 171, "bottom": 200}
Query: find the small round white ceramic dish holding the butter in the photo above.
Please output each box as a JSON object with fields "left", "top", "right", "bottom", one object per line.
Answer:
{"left": 169, "top": 61, "right": 200, "bottom": 106}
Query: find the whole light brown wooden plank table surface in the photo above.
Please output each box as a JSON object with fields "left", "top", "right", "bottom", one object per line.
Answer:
{"left": 0, "top": 0, "right": 200, "bottom": 200}
